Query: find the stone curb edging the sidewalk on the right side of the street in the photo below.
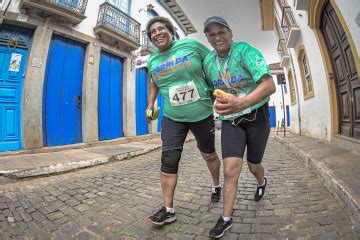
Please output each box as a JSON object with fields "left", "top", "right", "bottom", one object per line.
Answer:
{"left": 274, "top": 136, "right": 360, "bottom": 233}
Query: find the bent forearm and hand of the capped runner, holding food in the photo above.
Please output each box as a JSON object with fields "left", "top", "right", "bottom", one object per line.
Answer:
{"left": 215, "top": 75, "right": 276, "bottom": 115}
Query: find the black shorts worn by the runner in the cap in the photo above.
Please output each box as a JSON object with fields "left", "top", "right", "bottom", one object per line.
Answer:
{"left": 221, "top": 103, "right": 270, "bottom": 164}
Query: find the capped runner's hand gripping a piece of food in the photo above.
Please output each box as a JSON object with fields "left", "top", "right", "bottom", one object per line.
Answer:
{"left": 214, "top": 94, "right": 248, "bottom": 115}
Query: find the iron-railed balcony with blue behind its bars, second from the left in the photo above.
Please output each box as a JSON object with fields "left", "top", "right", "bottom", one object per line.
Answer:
{"left": 94, "top": 2, "right": 140, "bottom": 50}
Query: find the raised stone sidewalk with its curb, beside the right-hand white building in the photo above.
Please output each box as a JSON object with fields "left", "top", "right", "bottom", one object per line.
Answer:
{"left": 275, "top": 133, "right": 360, "bottom": 231}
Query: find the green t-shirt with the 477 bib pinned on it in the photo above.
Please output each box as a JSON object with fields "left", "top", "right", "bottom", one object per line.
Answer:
{"left": 147, "top": 39, "right": 213, "bottom": 122}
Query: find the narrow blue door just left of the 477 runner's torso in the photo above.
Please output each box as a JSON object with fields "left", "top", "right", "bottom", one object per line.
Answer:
{"left": 135, "top": 67, "right": 149, "bottom": 136}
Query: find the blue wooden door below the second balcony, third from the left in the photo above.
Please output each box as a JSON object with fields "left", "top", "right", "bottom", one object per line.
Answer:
{"left": 98, "top": 51, "right": 124, "bottom": 140}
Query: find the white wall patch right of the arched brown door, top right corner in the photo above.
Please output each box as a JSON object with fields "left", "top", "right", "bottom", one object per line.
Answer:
{"left": 335, "top": 0, "right": 360, "bottom": 56}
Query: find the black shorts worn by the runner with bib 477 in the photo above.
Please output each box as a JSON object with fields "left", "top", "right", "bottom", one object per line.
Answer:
{"left": 161, "top": 115, "right": 215, "bottom": 153}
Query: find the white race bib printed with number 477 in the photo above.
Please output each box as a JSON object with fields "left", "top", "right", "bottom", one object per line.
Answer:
{"left": 169, "top": 81, "right": 200, "bottom": 107}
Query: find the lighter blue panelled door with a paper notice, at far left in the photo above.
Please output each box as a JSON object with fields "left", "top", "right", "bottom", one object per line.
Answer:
{"left": 0, "top": 46, "right": 28, "bottom": 151}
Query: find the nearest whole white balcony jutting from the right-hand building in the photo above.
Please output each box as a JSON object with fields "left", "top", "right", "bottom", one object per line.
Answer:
{"left": 281, "top": 6, "right": 300, "bottom": 48}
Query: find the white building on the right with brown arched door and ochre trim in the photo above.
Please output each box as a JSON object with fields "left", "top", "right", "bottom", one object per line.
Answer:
{"left": 260, "top": 0, "right": 360, "bottom": 142}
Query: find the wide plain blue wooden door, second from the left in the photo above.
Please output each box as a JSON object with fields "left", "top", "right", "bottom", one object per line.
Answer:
{"left": 43, "top": 35, "right": 86, "bottom": 146}
